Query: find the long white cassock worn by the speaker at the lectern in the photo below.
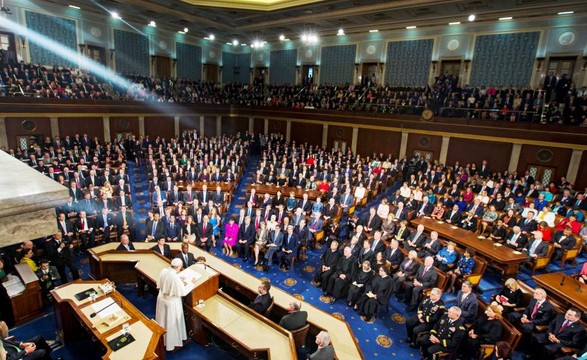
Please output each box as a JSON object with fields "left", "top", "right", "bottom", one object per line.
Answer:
{"left": 155, "top": 268, "right": 191, "bottom": 351}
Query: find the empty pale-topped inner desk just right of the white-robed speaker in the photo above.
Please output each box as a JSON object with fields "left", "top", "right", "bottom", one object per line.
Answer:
{"left": 191, "top": 292, "right": 296, "bottom": 360}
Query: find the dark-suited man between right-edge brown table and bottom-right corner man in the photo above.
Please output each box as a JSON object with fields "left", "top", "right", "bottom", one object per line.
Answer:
{"left": 510, "top": 288, "right": 555, "bottom": 335}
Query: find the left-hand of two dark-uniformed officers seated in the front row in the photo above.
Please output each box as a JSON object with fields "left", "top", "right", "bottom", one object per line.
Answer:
{"left": 406, "top": 288, "right": 445, "bottom": 348}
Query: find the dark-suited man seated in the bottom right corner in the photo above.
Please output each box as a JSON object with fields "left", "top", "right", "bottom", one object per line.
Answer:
{"left": 527, "top": 307, "right": 586, "bottom": 359}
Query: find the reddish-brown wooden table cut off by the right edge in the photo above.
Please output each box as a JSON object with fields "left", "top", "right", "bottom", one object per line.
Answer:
{"left": 532, "top": 272, "right": 587, "bottom": 313}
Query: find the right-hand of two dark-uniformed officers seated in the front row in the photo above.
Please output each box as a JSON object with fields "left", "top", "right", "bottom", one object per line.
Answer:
{"left": 417, "top": 306, "right": 466, "bottom": 359}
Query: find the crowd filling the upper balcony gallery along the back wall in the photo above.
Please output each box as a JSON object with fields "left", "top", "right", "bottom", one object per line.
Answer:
{"left": 0, "top": 62, "right": 587, "bottom": 126}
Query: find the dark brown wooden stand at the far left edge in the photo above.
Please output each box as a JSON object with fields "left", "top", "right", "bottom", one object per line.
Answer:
{"left": 0, "top": 264, "right": 43, "bottom": 325}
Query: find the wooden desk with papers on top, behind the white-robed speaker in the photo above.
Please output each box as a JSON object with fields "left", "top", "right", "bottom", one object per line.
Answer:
{"left": 51, "top": 279, "right": 165, "bottom": 360}
